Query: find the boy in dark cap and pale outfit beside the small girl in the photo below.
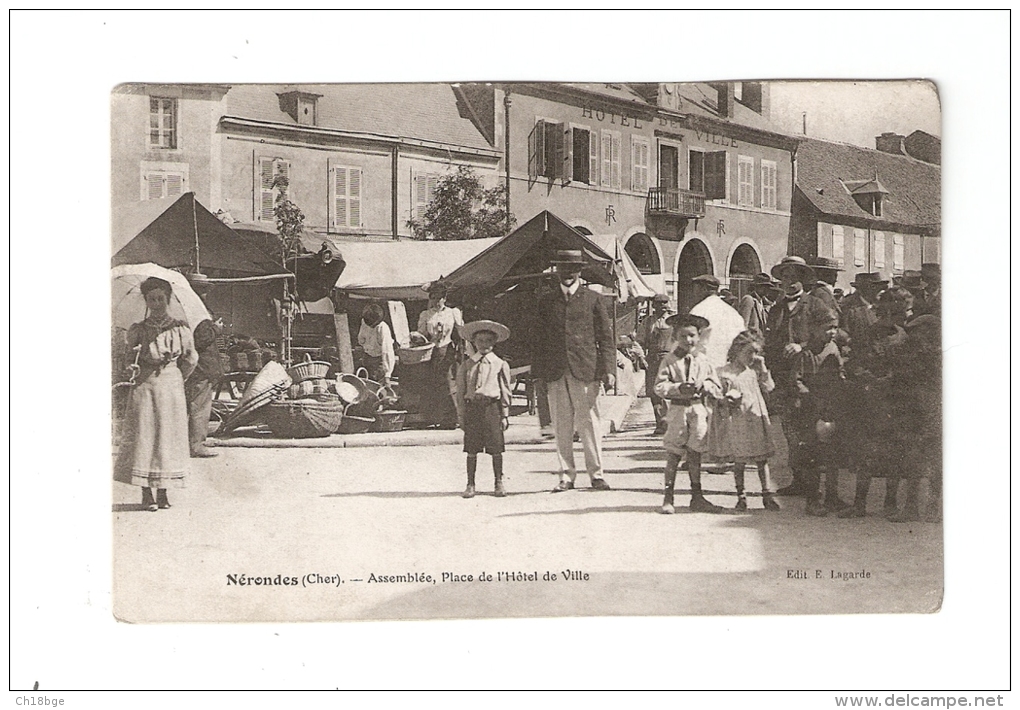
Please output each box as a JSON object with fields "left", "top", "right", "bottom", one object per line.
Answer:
{"left": 655, "top": 313, "right": 722, "bottom": 515}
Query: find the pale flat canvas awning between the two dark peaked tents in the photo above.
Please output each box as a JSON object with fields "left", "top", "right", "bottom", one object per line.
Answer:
{"left": 336, "top": 239, "right": 499, "bottom": 301}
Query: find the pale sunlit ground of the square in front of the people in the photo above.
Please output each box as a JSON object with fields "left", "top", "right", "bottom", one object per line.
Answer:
{"left": 113, "top": 400, "right": 942, "bottom": 621}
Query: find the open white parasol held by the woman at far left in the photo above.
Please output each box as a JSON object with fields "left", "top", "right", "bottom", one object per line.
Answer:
{"left": 110, "top": 264, "right": 211, "bottom": 328}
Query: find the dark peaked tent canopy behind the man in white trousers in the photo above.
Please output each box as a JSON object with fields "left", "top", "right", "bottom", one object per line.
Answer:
{"left": 443, "top": 211, "right": 614, "bottom": 292}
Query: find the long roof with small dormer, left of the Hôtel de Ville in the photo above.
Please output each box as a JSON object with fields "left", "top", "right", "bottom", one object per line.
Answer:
{"left": 223, "top": 84, "right": 492, "bottom": 150}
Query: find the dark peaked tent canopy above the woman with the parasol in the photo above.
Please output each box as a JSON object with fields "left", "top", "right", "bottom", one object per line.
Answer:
{"left": 112, "top": 193, "right": 292, "bottom": 280}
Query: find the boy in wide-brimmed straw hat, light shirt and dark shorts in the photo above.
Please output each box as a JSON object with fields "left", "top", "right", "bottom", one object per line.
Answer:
{"left": 457, "top": 320, "right": 510, "bottom": 498}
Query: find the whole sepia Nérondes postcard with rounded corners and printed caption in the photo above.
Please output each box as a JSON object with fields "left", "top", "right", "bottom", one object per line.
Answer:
{"left": 110, "top": 77, "right": 944, "bottom": 623}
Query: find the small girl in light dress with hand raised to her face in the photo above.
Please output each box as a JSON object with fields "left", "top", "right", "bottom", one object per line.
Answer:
{"left": 709, "top": 331, "right": 779, "bottom": 510}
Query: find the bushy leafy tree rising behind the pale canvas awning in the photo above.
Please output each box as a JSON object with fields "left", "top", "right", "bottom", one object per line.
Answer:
{"left": 407, "top": 165, "right": 517, "bottom": 241}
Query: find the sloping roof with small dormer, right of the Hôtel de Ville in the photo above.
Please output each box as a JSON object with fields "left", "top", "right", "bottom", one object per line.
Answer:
{"left": 797, "top": 139, "right": 941, "bottom": 227}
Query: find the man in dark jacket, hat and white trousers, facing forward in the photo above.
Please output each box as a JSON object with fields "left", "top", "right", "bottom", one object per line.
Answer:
{"left": 531, "top": 249, "right": 616, "bottom": 493}
